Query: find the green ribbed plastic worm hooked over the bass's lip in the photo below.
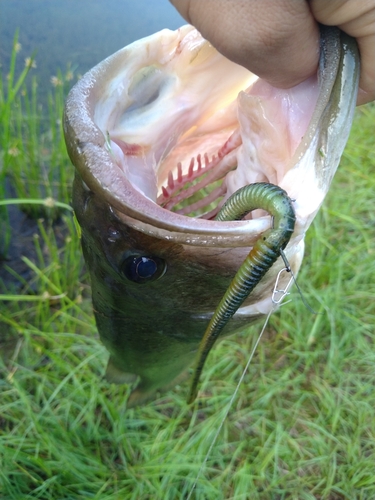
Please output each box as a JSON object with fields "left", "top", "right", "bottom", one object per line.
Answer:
{"left": 188, "top": 182, "right": 296, "bottom": 403}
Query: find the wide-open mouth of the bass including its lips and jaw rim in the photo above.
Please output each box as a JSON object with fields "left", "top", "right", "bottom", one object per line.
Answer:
{"left": 64, "top": 26, "right": 358, "bottom": 248}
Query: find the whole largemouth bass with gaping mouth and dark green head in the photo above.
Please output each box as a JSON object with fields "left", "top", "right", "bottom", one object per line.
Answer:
{"left": 64, "top": 26, "right": 359, "bottom": 405}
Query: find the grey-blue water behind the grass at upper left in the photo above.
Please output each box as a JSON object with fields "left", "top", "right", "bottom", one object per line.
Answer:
{"left": 0, "top": 0, "right": 185, "bottom": 92}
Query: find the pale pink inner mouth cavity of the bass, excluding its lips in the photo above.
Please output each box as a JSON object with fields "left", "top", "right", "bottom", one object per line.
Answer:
{"left": 96, "top": 26, "right": 319, "bottom": 219}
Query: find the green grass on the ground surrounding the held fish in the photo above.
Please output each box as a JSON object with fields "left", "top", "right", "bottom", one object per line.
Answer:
{"left": 0, "top": 42, "right": 375, "bottom": 500}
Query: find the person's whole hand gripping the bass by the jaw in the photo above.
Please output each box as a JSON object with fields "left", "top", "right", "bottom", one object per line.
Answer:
{"left": 170, "top": 0, "right": 375, "bottom": 105}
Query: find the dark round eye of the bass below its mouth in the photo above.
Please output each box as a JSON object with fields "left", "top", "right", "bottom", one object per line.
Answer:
{"left": 121, "top": 255, "right": 167, "bottom": 284}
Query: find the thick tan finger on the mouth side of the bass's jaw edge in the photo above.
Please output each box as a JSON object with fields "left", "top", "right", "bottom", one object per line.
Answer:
{"left": 171, "top": 0, "right": 319, "bottom": 88}
